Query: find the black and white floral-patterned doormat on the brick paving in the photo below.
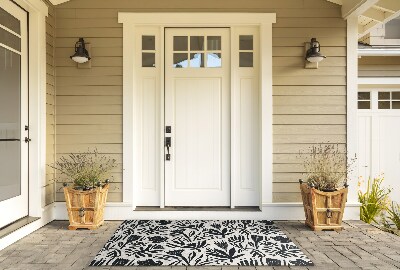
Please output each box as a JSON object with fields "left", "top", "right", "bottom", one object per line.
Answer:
{"left": 90, "top": 220, "right": 313, "bottom": 266}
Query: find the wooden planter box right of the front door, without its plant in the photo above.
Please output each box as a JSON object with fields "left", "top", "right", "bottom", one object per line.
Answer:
{"left": 300, "top": 183, "right": 348, "bottom": 231}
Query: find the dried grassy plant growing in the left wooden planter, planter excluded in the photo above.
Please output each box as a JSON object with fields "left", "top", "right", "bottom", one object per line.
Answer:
{"left": 49, "top": 149, "right": 116, "bottom": 190}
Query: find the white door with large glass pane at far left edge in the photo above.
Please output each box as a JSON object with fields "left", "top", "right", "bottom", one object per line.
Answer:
{"left": 0, "top": 1, "right": 28, "bottom": 228}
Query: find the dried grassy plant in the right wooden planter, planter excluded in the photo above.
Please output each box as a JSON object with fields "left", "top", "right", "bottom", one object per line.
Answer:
{"left": 299, "top": 144, "right": 355, "bottom": 191}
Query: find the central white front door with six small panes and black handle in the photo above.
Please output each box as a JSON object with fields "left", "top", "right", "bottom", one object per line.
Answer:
{"left": 165, "top": 28, "right": 231, "bottom": 206}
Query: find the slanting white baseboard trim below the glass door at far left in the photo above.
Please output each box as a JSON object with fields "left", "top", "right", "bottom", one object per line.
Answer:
{"left": 0, "top": 203, "right": 54, "bottom": 250}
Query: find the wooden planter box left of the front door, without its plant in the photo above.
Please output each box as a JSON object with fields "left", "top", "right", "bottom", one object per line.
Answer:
{"left": 64, "top": 184, "right": 109, "bottom": 230}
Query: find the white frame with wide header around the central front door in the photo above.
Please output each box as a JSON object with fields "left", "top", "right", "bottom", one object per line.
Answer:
{"left": 118, "top": 12, "right": 276, "bottom": 209}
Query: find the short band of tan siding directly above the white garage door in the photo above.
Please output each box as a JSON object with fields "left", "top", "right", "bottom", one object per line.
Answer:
{"left": 358, "top": 56, "right": 400, "bottom": 77}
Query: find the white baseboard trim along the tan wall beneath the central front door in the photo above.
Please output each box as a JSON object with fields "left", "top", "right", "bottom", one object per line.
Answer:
{"left": 54, "top": 202, "right": 360, "bottom": 220}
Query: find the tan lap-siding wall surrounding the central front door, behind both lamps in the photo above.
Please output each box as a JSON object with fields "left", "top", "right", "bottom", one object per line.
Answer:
{"left": 55, "top": 0, "right": 346, "bottom": 202}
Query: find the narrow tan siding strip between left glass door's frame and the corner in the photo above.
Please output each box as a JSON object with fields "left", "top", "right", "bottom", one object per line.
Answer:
{"left": 42, "top": 2, "right": 56, "bottom": 206}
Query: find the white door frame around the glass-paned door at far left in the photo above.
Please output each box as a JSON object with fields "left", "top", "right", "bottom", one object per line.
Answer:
{"left": 13, "top": 0, "right": 48, "bottom": 217}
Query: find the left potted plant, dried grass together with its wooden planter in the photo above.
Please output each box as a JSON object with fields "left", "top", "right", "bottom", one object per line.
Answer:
{"left": 50, "top": 149, "right": 116, "bottom": 230}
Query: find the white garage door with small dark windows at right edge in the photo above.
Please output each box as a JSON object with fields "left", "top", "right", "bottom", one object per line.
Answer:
{"left": 358, "top": 88, "right": 400, "bottom": 202}
